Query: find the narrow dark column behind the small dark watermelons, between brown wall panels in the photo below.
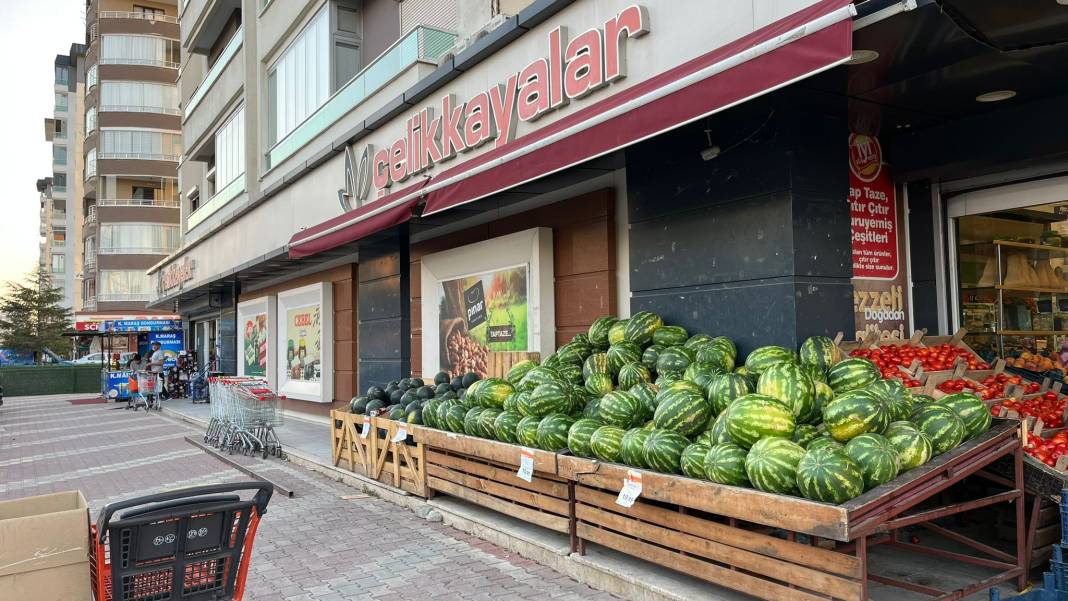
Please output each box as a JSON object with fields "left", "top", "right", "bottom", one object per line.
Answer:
{"left": 357, "top": 225, "right": 411, "bottom": 391}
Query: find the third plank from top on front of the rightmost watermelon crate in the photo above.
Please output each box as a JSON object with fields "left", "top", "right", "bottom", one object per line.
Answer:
{"left": 578, "top": 505, "right": 862, "bottom": 601}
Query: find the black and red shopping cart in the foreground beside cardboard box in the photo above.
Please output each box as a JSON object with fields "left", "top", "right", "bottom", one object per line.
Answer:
{"left": 90, "top": 480, "right": 274, "bottom": 601}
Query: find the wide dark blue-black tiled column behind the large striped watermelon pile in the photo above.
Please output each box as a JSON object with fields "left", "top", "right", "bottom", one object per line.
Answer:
{"left": 627, "top": 96, "right": 853, "bottom": 353}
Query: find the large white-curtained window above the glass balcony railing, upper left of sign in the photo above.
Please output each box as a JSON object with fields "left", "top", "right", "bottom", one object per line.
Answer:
{"left": 267, "top": 7, "right": 330, "bottom": 144}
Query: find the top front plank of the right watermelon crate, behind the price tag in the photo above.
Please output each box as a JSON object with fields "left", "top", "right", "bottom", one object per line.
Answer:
{"left": 556, "top": 455, "right": 849, "bottom": 542}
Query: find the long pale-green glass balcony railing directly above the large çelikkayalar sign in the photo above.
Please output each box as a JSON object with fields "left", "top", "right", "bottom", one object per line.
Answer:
{"left": 266, "top": 26, "right": 456, "bottom": 170}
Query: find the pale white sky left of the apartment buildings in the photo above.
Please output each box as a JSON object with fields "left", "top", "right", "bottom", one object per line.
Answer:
{"left": 0, "top": 0, "right": 85, "bottom": 281}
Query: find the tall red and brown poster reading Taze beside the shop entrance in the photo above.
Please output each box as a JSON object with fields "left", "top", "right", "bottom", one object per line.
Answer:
{"left": 849, "top": 133, "right": 911, "bottom": 341}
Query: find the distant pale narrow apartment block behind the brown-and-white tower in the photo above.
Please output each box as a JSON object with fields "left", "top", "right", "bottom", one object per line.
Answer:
{"left": 37, "top": 44, "right": 87, "bottom": 311}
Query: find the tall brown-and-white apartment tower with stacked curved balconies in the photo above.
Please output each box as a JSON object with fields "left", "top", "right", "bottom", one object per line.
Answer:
{"left": 78, "top": 0, "right": 183, "bottom": 314}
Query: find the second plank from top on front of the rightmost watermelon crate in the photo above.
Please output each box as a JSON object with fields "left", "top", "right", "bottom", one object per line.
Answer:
{"left": 575, "top": 486, "right": 862, "bottom": 579}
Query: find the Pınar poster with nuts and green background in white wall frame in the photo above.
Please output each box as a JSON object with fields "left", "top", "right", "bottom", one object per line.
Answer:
{"left": 438, "top": 265, "right": 530, "bottom": 377}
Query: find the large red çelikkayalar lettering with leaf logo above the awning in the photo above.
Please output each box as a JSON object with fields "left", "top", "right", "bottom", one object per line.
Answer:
{"left": 350, "top": 4, "right": 649, "bottom": 197}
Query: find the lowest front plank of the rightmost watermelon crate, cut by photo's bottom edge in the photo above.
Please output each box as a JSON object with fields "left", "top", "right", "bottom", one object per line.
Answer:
{"left": 578, "top": 523, "right": 827, "bottom": 601}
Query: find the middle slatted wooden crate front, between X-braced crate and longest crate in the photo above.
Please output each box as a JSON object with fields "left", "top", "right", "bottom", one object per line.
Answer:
{"left": 415, "top": 428, "right": 574, "bottom": 535}
